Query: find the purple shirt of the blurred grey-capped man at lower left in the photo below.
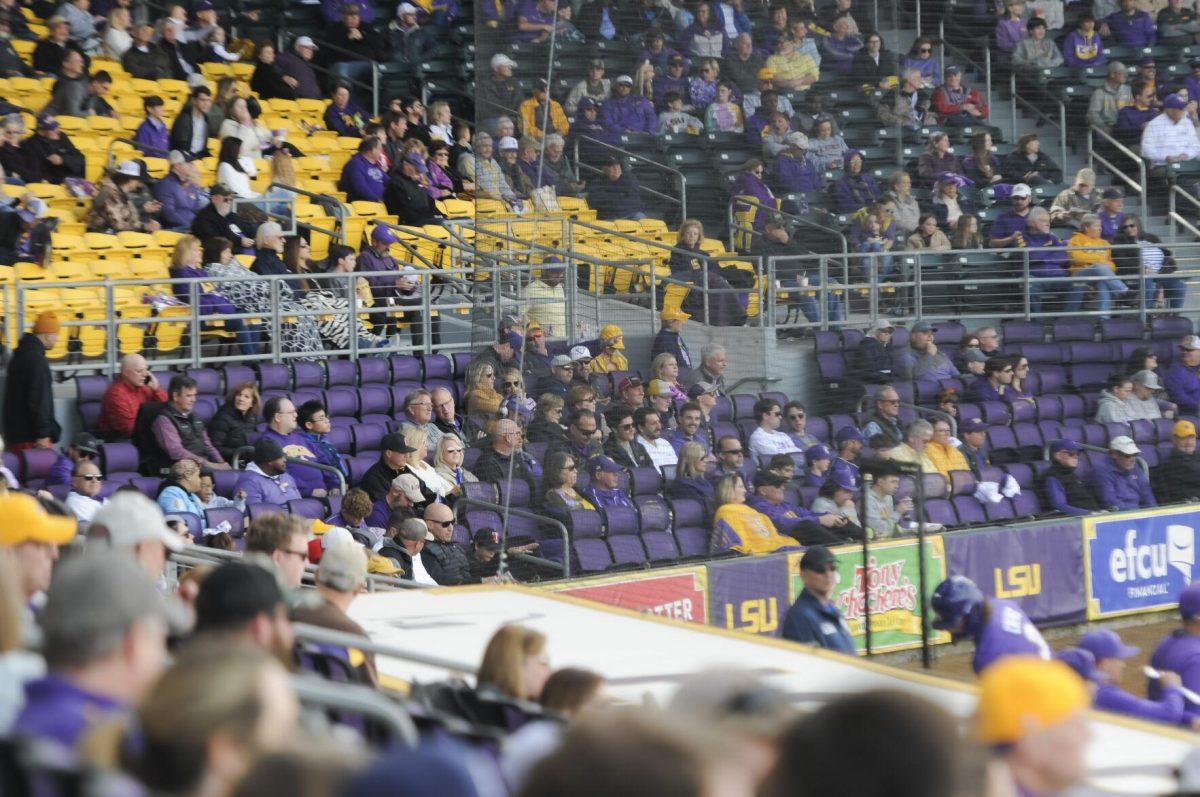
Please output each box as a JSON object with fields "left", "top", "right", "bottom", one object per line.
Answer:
{"left": 12, "top": 675, "right": 126, "bottom": 750}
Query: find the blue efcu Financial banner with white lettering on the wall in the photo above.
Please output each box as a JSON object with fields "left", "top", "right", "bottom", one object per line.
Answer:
{"left": 1082, "top": 508, "right": 1200, "bottom": 619}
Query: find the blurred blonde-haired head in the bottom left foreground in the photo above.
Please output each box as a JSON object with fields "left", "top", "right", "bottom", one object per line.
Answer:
{"left": 97, "top": 640, "right": 300, "bottom": 797}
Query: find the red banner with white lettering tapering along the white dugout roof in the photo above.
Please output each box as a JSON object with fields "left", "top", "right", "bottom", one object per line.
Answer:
{"left": 547, "top": 567, "right": 708, "bottom": 625}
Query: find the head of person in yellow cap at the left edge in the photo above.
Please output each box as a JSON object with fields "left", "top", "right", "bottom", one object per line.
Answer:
{"left": 0, "top": 492, "right": 77, "bottom": 603}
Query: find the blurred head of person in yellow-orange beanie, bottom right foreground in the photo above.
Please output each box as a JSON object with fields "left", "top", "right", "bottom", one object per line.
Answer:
{"left": 974, "top": 657, "right": 1092, "bottom": 797}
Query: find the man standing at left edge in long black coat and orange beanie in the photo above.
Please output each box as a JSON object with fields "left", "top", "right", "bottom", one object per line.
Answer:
{"left": 4, "top": 311, "right": 62, "bottom": 454}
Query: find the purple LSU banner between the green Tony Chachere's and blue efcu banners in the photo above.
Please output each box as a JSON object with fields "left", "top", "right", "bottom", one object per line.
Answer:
{"left": 944, "top": 519, "right": 1087, "bottom": 625}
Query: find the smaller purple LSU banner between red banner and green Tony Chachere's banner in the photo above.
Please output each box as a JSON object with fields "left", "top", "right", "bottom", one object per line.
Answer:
{"left": 708, "top": 556, "right": 791, "bottom": 636}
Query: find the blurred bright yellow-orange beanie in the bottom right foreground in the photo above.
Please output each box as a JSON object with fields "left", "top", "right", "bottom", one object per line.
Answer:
{"left": 976, "top": 657, "right": 1092, "bottom": 744}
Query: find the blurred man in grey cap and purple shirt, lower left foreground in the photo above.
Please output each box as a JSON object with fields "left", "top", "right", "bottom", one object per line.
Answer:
{"left": 12, "top": 550, "right": 172, "bottom": 751}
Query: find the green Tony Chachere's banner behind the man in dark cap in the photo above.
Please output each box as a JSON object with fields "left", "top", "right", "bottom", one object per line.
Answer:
{"left": 787, "top": 537, "right": 949, "bottom": 653}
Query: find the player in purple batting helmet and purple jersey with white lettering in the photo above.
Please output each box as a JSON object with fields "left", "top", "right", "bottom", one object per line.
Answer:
{"left": 930, "top": 576, "right": 1050, "bottom": 675}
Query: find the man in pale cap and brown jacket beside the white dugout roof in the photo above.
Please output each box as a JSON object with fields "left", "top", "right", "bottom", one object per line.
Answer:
{"left": 292, "top": 542, "right": 379, "bottom": 684}
